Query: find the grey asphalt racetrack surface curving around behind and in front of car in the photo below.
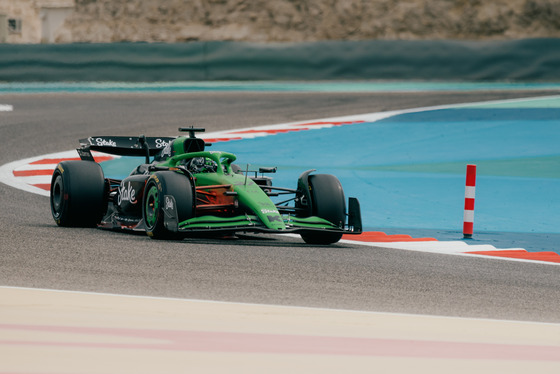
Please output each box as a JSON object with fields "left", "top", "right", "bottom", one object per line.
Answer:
{"left": 0, "top": 91, "right": 560, "bottom": 322}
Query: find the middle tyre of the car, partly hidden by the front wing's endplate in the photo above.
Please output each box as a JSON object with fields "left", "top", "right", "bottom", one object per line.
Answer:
{"left": 142, "top": 171, "right": 194, "bottom": 240}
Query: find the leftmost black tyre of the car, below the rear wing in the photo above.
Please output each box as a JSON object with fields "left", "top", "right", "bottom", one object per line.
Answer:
{"left": 50, "top": 161, "right": 107, "bottom": 227}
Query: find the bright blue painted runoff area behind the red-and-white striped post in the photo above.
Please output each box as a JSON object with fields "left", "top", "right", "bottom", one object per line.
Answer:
{"left": 219, "top": 109, "right": 560, "bottom": 233}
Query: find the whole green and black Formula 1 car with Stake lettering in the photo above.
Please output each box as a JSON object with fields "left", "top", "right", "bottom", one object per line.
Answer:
{"left": 50, "top": 128, "right": 362, "bottom": 244}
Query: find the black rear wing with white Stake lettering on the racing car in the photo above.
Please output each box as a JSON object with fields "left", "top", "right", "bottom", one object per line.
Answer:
{"left": 77, "top": 135, "right": 176, "bottom": 161}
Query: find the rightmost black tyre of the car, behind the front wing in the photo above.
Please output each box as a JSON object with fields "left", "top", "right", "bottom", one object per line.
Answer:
{"left": 301, "top": 174, "right": 346, "bottom": 244}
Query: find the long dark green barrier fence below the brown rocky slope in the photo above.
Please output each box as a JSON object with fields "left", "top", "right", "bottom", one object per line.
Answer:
{"left": 0, "top": 39, "right": 560, "bottom": 82}
